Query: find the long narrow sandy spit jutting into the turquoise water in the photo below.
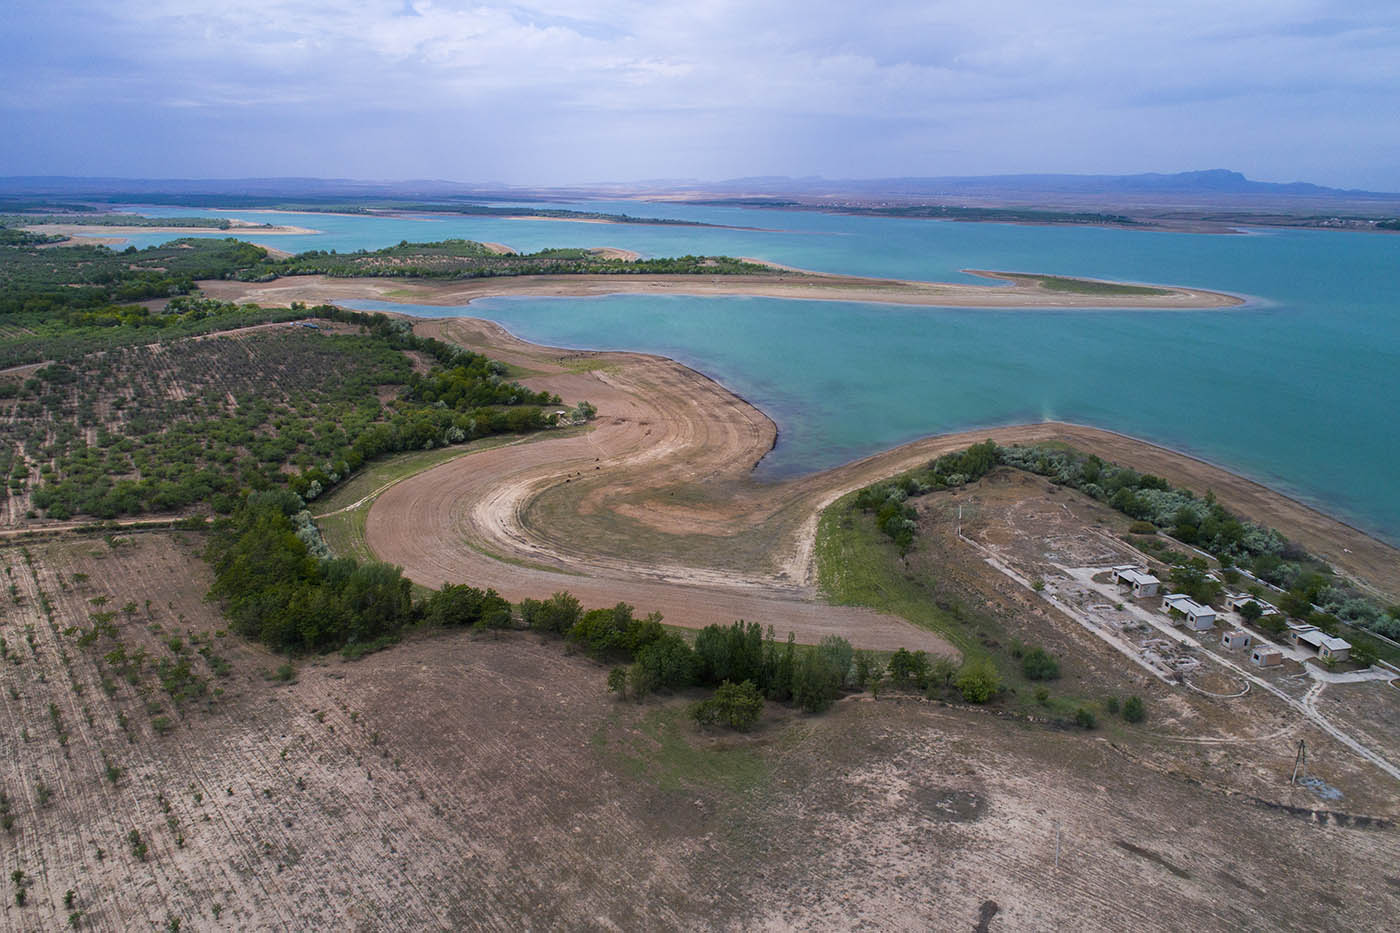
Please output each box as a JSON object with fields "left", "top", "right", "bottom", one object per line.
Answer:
{"left": 200, "top": 264, "right": 1243, "bottom": 311}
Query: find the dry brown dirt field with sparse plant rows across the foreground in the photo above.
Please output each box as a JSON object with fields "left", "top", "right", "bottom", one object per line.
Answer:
{"left": 0, "top": 534, "right": 1400, "bottom": 930}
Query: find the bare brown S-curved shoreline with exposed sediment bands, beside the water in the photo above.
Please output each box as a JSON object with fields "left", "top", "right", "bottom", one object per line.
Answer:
{"left": 365, "top": 318, "right": 1397, "bottom": 653}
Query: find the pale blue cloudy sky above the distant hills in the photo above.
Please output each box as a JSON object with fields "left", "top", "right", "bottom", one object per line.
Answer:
{"left": 0, "top": 0, "right": 1400, "bottom": 191}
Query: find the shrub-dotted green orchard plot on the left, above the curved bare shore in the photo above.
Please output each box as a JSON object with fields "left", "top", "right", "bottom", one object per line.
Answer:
{"left": 0, "top": 325, "right": 413, "bottom": 523}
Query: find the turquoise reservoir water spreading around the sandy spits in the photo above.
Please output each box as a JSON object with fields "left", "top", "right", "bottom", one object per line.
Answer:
{"left": 117, "top": 202, "right": 1400, "bottom": 541}
